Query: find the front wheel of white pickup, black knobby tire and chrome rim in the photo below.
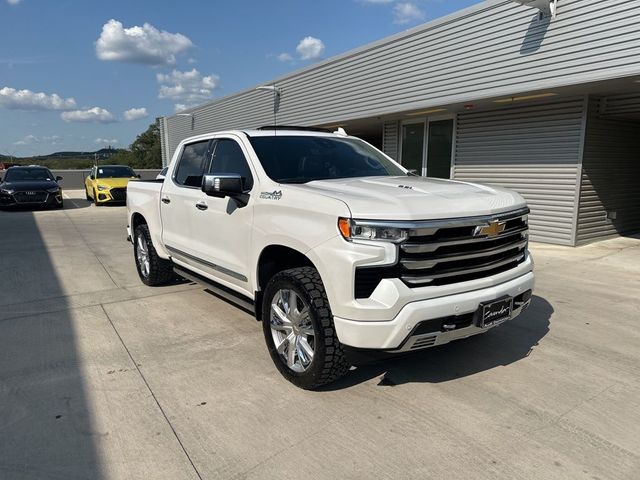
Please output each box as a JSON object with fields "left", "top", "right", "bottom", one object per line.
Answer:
{"left": 262, "top": 267, "right": 350, "bottom": 390}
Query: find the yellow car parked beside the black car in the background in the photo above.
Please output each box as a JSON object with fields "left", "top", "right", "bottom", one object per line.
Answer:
{"left": 84, "top": 165, "right": 140, "bottom": 206}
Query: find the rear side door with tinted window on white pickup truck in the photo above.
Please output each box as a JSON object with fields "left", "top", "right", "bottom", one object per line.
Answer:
{"left": 160, "top": 140, "right": 211, "bottom": 258}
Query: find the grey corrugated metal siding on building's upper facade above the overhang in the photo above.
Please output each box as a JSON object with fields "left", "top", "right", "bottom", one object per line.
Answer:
{"left": 162, "top": 0, "right": 640, "bottom": 159}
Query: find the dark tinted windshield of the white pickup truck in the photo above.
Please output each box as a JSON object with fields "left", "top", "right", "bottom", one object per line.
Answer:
{"left": 250, "top": 135, "right": 406, "bottom": 183}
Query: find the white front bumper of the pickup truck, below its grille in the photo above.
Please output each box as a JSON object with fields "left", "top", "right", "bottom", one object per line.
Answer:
{"left": 334, "top": 272, "right": 534, "bottom": 352}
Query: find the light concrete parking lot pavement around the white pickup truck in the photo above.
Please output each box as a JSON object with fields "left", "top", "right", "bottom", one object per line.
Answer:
{"left": 0, "top": 191, "right": 640, "bottom": 480}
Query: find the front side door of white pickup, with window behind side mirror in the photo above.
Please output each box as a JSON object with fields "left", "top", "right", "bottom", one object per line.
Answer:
{"left": 191, "top": 136, "right": 254, "bottom": 294}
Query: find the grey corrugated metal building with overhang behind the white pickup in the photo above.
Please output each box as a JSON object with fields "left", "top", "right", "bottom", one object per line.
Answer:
{"left": 160, "top": 0, "right": 640, "bottom": 245}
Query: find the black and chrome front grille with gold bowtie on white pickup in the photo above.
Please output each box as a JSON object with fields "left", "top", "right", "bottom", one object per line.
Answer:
{"left": 355, "top": 209, "right": 529, "bottom": 298}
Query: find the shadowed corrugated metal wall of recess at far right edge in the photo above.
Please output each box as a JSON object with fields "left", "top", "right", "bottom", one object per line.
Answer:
{"left": 577, "top": 99, "right": 640, "bottom": 243}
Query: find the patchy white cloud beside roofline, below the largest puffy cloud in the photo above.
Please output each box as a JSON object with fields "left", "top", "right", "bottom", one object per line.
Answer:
{"left": 156, "top": 68, "right": 220, "bottom": 111}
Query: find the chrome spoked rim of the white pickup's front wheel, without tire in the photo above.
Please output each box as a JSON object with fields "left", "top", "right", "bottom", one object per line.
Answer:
{"left": 270, "top": 289, "right": 315, "bottom": 372}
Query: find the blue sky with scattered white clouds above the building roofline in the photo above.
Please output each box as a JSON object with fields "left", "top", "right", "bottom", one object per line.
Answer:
{"left": 0, "top": 0, "right": 477, "bottom": 156}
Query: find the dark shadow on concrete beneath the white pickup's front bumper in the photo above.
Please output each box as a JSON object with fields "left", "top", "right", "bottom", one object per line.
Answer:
{"left": 322, "top": 295, "right": 553, "bottom": 391}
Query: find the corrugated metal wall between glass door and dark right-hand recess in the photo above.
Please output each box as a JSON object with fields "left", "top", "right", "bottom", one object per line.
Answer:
{"left": 454, "top": 98, "right": 585, "bottom": 245}
